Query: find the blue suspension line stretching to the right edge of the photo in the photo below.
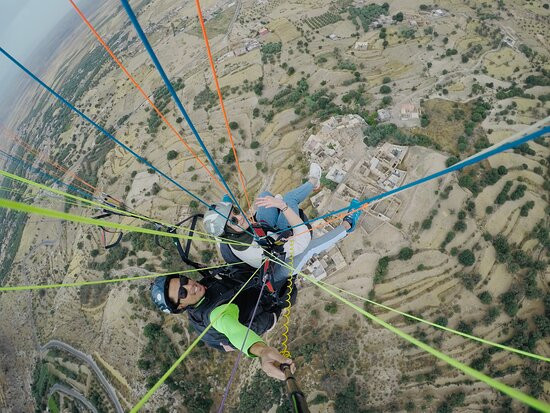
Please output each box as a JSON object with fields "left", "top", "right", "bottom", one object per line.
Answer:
{"left": 277, "top": 126, "right": 550, "bottom": 232}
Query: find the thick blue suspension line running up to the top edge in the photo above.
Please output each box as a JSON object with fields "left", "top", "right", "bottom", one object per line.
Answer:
{"left": 120, "top": 0, "right": 256, "bottom": 232}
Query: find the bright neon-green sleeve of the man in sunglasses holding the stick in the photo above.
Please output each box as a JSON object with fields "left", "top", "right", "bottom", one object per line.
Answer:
{"left": 210, "top": 304, "right": 263, "bottom": 357}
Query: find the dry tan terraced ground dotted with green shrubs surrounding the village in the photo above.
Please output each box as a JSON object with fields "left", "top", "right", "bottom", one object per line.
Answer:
{"left": 0, "top": 0, "right": 550, "bottom": 412}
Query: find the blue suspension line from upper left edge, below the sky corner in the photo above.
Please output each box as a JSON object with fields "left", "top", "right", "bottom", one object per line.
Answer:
{"left": 0, "top": 47, "right": 239, "bottom": 230}
